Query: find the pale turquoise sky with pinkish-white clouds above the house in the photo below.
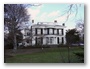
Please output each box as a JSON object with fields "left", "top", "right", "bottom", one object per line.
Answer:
{"left": 28, "top": 3, "right": 84, "bottom": 29}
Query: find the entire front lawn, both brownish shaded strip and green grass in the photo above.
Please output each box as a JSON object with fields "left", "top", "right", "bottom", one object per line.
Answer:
{"left": 4, "top": 46, "right": 84, "bottom": 63}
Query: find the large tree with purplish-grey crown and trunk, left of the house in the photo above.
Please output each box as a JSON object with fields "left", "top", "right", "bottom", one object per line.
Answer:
{"left": 4, "top": 4, "right": 29, "bottom": 50}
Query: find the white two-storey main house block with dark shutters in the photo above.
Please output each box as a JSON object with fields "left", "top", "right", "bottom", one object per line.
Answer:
{"left": 31, "top": 21, "right": 66, "bottom": 45}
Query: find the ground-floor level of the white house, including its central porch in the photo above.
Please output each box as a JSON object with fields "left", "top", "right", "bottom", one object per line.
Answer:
{"left": 34, "top": 37, "right": 65, "bottom": 45}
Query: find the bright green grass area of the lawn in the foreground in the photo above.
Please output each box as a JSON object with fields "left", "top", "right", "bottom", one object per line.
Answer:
{"left": 6, "top": 47, "right": 84, "bottom": 63}
